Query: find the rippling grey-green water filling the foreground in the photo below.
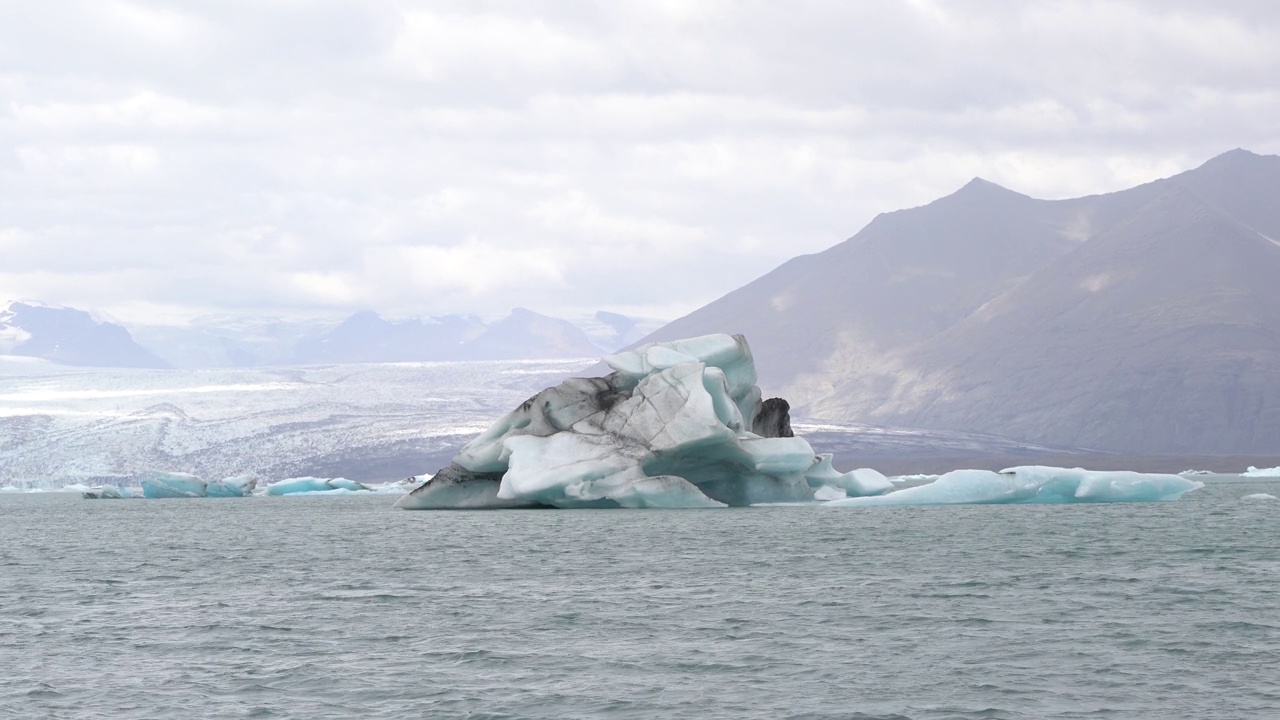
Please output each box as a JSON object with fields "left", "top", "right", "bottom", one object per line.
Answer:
{"left": 0, "top": 483, "right": 1280, "bottom": 720}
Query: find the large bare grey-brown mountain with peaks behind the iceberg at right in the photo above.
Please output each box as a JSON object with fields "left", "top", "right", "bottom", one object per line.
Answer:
{"left": 624, "top": 150, "right": 1280, "bottom": 454}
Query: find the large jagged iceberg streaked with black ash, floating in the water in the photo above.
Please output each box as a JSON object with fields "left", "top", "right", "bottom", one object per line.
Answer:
{"left": 398, "top": 334, "right": 892, "bottom": 510}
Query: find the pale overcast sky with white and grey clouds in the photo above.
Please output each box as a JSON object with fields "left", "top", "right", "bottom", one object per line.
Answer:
{"left": 0, "top": 0, "right": 1280, "bottom": 322}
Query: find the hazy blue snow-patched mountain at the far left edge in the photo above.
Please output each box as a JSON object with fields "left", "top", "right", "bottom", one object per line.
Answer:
{"left": 0, "top": 302, "right": 169, "bottom": 368}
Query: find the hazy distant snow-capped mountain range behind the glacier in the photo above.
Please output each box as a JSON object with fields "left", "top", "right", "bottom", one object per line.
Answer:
{"left": 0, "top": 302, "right": 662, "bottom": 368}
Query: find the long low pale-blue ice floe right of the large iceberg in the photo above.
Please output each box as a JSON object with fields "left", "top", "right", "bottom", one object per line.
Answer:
{"left": 827, "top": 465, "right": 1204, "bottom": 507}
